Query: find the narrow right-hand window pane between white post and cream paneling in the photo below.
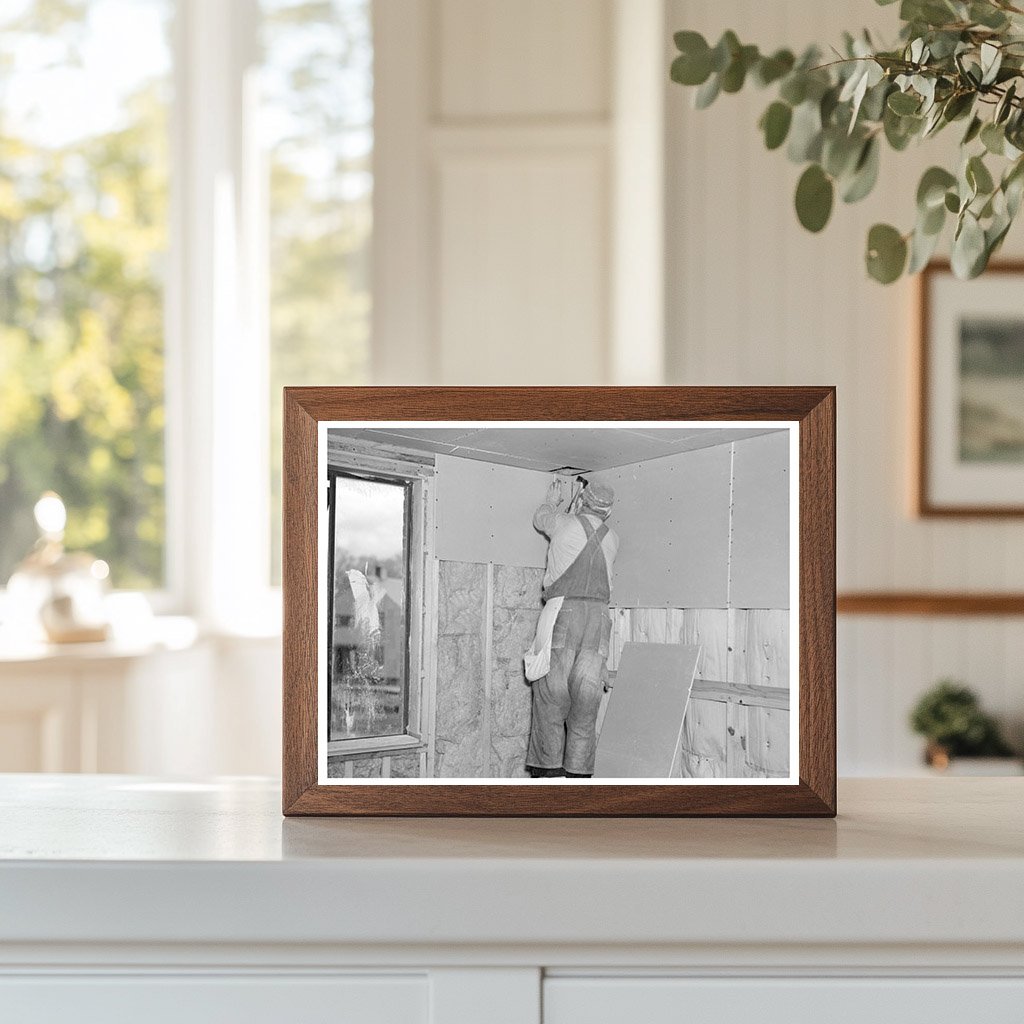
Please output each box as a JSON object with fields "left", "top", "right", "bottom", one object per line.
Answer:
{"left": 261, "top": 0, "right": 374, "bottom": 584}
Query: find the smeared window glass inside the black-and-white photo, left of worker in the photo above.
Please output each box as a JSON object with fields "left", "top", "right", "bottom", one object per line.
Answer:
{"left": 328, "top": 474, "right": 412, "bottom": 740}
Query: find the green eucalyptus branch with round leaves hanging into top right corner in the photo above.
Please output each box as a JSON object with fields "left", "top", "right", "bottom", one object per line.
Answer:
{"left": 671, "top": 0, "right": 1024, "bottom": 284}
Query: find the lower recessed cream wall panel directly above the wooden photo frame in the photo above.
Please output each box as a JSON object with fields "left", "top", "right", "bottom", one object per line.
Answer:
{"left": 437, "top": 143, "right": 609, "bottom": 384}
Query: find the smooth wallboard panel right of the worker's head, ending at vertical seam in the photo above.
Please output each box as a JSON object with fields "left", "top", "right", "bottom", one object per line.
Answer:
{"left": 592, "top": 442, "right": 746, "bottom": 608}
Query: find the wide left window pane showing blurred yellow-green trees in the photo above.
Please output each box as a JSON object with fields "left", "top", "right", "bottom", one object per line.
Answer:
{"left": 0, "top": 0, "right": 173, "bottom": 589}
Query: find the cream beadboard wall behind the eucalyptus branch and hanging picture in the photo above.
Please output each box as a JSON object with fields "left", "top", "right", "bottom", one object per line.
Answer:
{"left": 666, "top": 0, "right": 1024, "bottom": 774}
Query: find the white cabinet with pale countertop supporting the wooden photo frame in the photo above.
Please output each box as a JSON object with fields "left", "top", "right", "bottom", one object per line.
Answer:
{"left": 0, "top": 775, "right": 1024, "bottom": 1024}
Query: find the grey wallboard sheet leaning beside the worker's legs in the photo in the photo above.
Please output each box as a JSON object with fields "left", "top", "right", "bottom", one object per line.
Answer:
{"left": 594, "top": 643, "right": 700, "bottom": 778}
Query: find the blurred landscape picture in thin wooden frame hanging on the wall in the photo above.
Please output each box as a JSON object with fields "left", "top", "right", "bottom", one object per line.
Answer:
{"left": 916, "top": 263, "right": 1024, "bottom": 516}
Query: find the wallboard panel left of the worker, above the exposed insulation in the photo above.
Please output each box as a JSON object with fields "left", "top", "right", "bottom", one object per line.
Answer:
{"left": 434, "top": 455, "right": 551, "bottom": 568}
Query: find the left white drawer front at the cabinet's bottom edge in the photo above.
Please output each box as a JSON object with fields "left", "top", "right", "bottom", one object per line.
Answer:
{"left": 0, "top": 975, "right": 428, "bottom": 1024}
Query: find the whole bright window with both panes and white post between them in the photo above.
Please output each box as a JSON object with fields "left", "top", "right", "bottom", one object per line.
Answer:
{"left": 0, "top": 0, "right": 374, "bottom": 614}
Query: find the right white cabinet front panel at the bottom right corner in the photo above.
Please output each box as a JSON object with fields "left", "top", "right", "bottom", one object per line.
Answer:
{"left": 544, "top": 977, "right": 1024, "bottom": 1024}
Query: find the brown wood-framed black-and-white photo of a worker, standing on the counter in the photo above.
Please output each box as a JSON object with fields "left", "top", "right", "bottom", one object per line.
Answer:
{"left": 284, "top": 387, "right": 836, "bottom": 816}
